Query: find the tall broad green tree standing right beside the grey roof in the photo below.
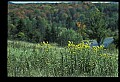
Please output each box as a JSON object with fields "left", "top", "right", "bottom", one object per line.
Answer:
{"left": 86, "top": 7, "right": 111, "bottom": 45}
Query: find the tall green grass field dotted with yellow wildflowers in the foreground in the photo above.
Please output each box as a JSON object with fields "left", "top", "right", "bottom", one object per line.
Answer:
{"left": 7, "top": 40, "right": 118, "bottom": 77}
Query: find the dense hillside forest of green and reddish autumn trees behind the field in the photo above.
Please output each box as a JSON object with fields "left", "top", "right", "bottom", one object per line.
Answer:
{"left": 8, "top": 2, "right": 118, "bottom": 46}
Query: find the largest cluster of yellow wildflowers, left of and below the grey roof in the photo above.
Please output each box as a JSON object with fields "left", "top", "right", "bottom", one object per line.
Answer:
{"left": 68, "top": 40, "right": 104, "bottom": 54}
